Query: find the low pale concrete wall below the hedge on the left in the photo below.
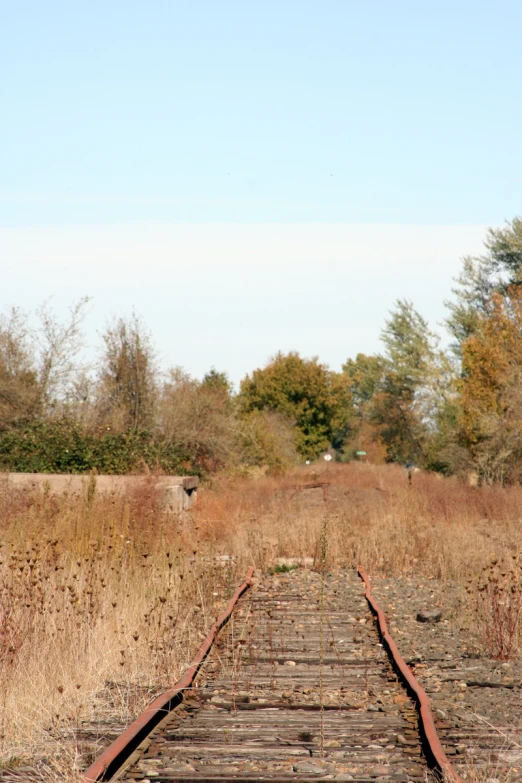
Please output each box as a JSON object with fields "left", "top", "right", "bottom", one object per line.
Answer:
{"left": 0, "top": 473, "right": 199, "bottom": 513}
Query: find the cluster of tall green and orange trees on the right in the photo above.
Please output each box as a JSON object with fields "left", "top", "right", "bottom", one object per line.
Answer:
{"left": 343, "top": 217, "right": 522, "bottom": 484}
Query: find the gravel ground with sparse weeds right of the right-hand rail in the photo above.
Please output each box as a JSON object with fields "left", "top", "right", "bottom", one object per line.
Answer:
{"left": 372, "top": 576, "right": 522, "bottom": 780}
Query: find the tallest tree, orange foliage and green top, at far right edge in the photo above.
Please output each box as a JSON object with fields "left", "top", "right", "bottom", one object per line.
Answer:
{"left": 438, "top": 217, "right": 522, "bottom": 481}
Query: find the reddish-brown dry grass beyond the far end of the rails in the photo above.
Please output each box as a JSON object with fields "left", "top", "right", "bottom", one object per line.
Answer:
{"left": 198, "top": 465, "right": 522, "bottom": 581}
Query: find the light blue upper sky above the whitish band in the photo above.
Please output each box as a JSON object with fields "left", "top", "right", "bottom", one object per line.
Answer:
{"left": 4, "top": 0, "right": 522, "bottom": 225}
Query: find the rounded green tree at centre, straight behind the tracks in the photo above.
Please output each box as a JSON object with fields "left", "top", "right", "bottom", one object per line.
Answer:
{"left": 239, "top": 352, "right": 351, "bottom": 458}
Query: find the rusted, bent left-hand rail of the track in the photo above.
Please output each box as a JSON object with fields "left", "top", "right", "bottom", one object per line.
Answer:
{"left": 81, "top": 566, "right": 254, "bottom": 783}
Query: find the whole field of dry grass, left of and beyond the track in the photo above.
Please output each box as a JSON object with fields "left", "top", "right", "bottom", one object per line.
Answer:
{"left": 0, "top": 464, "right": 522, "bottom": 780}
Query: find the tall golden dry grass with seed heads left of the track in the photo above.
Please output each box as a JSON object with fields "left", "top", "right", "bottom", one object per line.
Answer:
{"left": 0, "top": 478, "right": 241, "bottom": 780}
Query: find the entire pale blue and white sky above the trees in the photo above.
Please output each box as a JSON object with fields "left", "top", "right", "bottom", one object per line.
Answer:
{"left": 0, "top": 0, "right": 522, "bottom": 383}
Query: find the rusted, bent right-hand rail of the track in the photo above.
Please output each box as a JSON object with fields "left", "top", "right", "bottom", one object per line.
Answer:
{"left": 357, "top": 566, "right": 464, "bottom": 783}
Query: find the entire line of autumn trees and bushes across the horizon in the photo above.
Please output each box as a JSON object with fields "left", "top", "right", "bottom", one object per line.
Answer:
{"left": 0, "top": 218, "right": 522, "bottom": 483}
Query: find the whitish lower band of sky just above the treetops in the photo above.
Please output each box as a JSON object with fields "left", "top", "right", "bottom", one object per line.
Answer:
{"left": 0, "top": 223, "right": 484, "bottom": 387}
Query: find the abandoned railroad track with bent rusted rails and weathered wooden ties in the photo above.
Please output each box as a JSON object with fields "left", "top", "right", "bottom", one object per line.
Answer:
{"left": 77, "top": 570, "right": 522, "bottom": 783}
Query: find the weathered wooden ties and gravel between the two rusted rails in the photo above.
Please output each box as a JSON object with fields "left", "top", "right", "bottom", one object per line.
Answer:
{"left": 115, "top": 571, "right": 442, "bottom": 783}
